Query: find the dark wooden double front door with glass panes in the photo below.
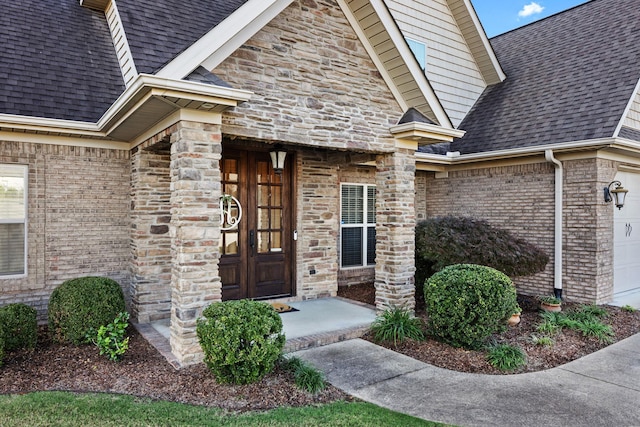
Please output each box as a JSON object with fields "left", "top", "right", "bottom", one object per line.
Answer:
{"left": 219, "top": 148, "right": 294, "bottom": 300}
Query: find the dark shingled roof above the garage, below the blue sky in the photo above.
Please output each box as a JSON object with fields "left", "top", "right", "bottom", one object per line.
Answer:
{"left": 450, "top": 0, "right": 640, "bottom": 153}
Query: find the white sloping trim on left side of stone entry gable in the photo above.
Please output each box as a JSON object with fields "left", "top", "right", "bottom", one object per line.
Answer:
{"left": 156, "top": 0, "right": 293, "bottom": 80}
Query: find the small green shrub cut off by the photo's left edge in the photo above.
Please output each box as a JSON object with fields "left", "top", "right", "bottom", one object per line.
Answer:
{"left": 0, "top": 303, "right": 38, "bottom": 351}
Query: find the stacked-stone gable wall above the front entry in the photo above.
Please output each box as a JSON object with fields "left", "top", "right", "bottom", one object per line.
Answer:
{"left": 213, "top": 0, "right": 403, "bottom": 151}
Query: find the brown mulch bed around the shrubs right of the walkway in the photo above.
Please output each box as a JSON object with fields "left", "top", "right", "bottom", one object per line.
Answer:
{"left": 338, "top": 284, "right": 640, "bottom": 375}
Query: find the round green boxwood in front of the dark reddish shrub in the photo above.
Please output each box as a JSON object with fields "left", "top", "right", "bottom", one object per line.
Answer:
{"left": 424, "top": 264, "right": 520, "bottom": 348}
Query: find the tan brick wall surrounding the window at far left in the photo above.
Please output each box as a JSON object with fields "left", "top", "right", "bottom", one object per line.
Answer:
{"left": 0, "top": 141, "right": 130, "bottom": 320}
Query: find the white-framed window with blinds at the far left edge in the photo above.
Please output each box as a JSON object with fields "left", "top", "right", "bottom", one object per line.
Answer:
{"left": 0, "top": 164, "right": 27, "bottom": 278}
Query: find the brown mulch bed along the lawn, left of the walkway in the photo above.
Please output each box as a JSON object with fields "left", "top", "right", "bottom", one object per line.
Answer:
{"left": 0, "top": 327, "right": 350, "bottom": 412}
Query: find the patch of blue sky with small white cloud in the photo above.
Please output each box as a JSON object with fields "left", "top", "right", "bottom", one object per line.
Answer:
{"left": 471, "top": 0, "right": 586, "bottom": 37}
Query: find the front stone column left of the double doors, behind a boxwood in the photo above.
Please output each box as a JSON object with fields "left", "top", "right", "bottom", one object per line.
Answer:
{"left": 170, "top": 121, "right": 222, "bottom": 366}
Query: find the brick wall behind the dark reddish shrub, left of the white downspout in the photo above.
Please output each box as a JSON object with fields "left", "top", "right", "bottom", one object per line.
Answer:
{"left": 416, "top": 163, "right": 555, "bottom": 295}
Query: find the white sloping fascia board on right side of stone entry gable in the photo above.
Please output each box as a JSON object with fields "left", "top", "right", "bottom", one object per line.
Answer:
{"left": 364, "top": 0, "right": 453, "bottom": 129}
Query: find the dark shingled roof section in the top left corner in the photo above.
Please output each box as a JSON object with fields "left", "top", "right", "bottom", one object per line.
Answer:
{"left": 0, "top": 0, "right": 124, "bottom": 122}
